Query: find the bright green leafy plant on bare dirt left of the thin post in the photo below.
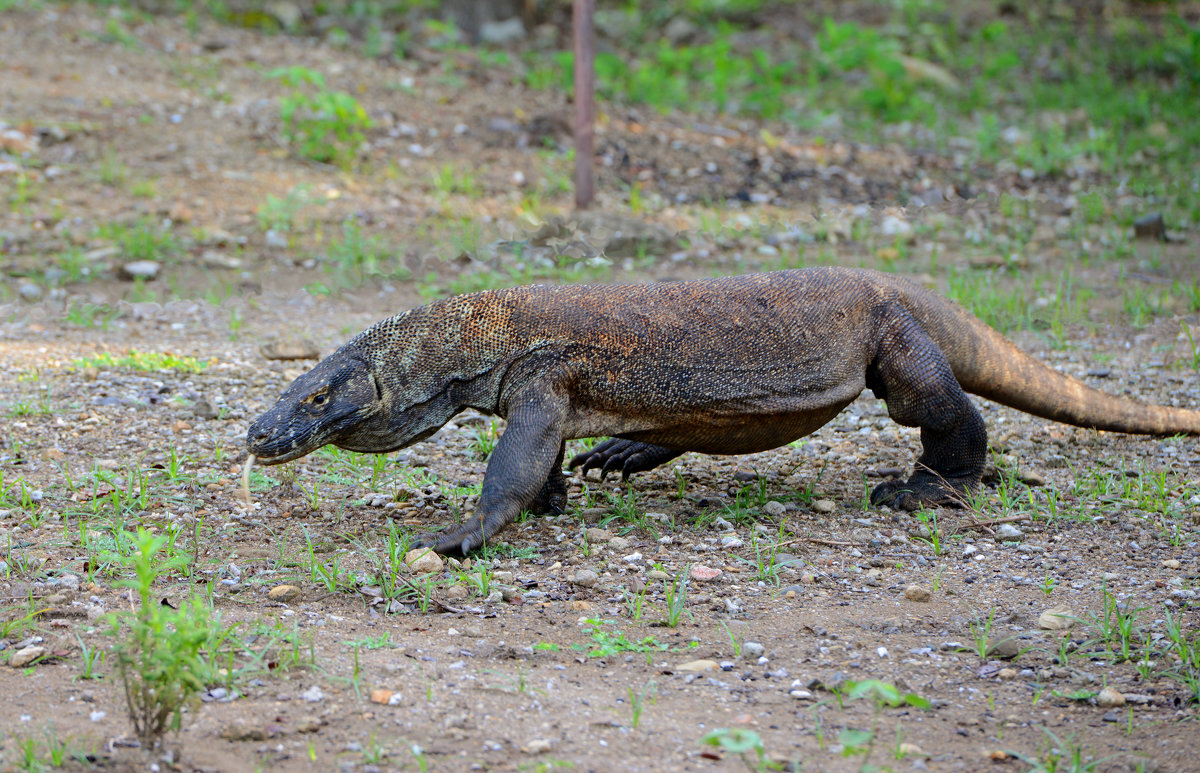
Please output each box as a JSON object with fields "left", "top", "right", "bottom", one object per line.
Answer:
{"left": 266, "top": 65, "right": 371, "bottom": 167}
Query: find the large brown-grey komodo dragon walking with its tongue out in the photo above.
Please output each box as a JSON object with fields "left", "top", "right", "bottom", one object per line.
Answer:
{"left": 247, "top": 268, "right": 1200, "bottom": 553}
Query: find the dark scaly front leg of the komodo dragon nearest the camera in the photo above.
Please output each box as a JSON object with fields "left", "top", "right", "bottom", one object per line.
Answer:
{"left": 414, "top": 387, "right": 565, "bottom": 556}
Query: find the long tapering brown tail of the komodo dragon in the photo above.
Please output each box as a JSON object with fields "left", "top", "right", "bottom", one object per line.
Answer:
{"left": 895, "top": 280, "right": 1200, "bottom": 435}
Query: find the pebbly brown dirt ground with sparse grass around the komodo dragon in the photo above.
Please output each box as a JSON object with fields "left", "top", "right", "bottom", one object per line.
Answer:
{"left": 0, "top": 7, "right": 1200, "bottom": 772}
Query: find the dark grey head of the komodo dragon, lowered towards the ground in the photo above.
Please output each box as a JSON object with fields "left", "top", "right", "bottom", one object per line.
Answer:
{"left": 246, "top": 346, "right": 396, "bottom": 465}
